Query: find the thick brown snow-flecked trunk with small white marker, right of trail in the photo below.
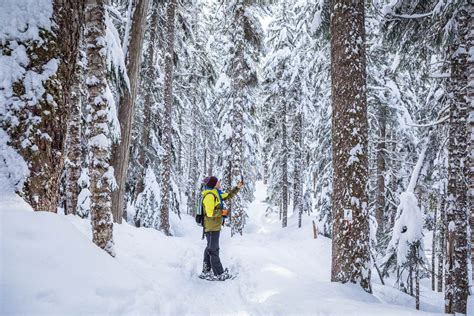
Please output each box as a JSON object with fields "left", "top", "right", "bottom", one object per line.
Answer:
{"left": 331, "top": 0, "right": 372, "bottom": 292}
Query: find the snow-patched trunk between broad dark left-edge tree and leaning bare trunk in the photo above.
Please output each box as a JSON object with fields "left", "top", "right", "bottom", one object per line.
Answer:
{"left": 85, "top": 0, "right": 115, "bottom": 256}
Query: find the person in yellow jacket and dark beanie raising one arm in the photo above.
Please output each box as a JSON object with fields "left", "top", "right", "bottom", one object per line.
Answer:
{"left": 200, "top": 176, "right": 243, "bottom": 281}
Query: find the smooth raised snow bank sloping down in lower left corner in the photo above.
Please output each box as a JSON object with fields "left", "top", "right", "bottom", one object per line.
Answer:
{"left": 0, "top": 205, "right": 159, "bottom": 315}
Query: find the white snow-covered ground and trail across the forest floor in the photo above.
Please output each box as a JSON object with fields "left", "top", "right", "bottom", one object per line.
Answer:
{"left": 0, "top": 183, "right": 466, "bottom": 315}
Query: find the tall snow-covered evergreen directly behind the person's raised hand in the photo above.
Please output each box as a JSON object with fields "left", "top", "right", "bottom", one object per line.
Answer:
{"left": 212, "top": 0, "right": 262, "bottom": 235}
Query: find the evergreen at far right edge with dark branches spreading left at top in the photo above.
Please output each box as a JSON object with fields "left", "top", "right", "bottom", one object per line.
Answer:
{"left": 384, "top": 1, "right": 472, "bottom": 313}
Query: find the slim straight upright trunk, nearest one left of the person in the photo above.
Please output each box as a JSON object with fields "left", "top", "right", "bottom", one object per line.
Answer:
{"left": 160, "top": 0, "right": 176, "bottom": 235}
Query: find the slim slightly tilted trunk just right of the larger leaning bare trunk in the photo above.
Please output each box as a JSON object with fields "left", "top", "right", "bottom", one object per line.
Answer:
{"left": 135, "top": 1, "right": 160, "bottom": 200}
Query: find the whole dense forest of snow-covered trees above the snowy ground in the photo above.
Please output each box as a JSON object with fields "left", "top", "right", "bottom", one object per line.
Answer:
{"left": 0, "top": 0, "right": 474, "bottom": 314}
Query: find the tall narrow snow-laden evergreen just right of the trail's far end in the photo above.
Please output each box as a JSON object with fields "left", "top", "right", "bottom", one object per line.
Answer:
{"left": 263, "top": 3, "right": 294, "bottom": 227}
